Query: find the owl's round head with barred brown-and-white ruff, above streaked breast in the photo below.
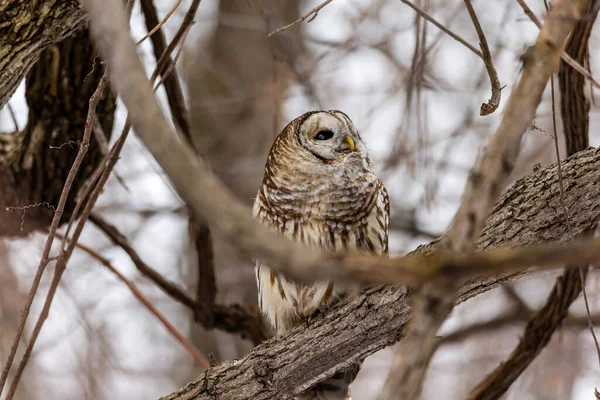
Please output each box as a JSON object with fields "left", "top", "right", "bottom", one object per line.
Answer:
{"left": 261, "top": 110, "right": 378, "bottom": 209}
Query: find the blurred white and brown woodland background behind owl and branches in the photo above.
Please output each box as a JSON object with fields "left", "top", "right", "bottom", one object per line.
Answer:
{"left": 0, "top": 0, "right": 600, "bottom": 400}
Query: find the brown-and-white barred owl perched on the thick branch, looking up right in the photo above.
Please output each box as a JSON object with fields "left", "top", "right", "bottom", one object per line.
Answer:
{"left": 253, "top": 110, "right": 390, "bottom": 400}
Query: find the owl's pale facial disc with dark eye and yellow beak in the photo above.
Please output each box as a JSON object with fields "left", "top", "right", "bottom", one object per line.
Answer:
{"left": 298, "top": 112, "right": 363, "bottom": 161}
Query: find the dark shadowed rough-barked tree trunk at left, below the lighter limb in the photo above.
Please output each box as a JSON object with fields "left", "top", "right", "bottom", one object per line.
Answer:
{"left": 0, "top": 25, "right": 115, "bottom": 236}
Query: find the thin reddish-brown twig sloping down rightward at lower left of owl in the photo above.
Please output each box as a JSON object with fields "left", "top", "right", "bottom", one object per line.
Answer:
{"left": 65, "top": 235, "right": 210, "bottom": 369}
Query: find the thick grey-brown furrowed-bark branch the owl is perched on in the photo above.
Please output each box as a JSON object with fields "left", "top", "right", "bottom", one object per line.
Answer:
{"left": 163, "top": 148, "right": 600, "bottom": 400}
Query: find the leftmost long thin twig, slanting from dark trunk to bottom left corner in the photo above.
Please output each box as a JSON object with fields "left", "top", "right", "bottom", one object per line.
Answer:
{"left": 0, "top": 71, "right": 108, "bottom": 399}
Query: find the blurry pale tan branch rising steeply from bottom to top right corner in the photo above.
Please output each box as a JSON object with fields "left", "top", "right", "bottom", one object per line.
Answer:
{"left": 380, "top": 0, "right": 586, "bottom": 400}
